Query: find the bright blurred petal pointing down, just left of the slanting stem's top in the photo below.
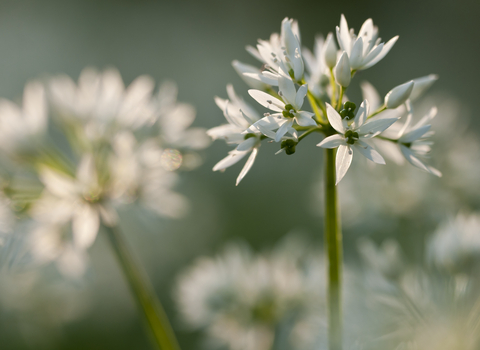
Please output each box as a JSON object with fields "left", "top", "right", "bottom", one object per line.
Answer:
{"left": 72, "top": 204, "right": 100, "bottom": 248}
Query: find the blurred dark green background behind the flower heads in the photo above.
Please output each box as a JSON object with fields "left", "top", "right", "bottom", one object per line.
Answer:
{"left": 0, "top": 0, "right": 480, "bottom": 350}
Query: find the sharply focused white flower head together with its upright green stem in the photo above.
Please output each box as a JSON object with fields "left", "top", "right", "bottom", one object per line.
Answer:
{"left": 210, "top": 15, "right": 440, "bottom": 350}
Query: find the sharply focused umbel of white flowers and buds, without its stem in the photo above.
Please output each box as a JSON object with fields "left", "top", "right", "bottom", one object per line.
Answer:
{"left": 207, "top": 15, "right": 441, "bottom": 185}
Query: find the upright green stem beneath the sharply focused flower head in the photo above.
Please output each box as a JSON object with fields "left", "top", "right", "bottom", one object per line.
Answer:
{"left": 325, "top": 149, "right": 342, "bottom": 350}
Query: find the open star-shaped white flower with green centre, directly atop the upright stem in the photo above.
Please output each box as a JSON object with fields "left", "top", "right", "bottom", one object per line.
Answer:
{"left": 317, "top": 100, "right": 398, "bottom": 184}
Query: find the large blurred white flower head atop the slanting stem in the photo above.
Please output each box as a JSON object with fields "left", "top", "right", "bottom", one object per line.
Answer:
{"left": 0, "top": 68, "right": 210, "bottom": 276}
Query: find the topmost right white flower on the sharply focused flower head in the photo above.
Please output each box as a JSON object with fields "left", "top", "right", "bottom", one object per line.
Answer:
{"left": 337, "top": 14, "right": 398, "bottom": 70}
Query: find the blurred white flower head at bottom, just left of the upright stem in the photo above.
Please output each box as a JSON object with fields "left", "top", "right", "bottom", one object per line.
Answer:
{"left": 175, "top": 238, "right": 323, "bottom": 350}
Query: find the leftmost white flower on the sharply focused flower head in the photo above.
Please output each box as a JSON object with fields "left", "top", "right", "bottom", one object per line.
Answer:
{"left": 207, "top": 85, "right": 262, "bottom": 185}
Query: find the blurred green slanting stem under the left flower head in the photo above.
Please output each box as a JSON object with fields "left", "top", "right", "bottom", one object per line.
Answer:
{"left": 103, "top": 225, "right": 180, "bottom": 350}
